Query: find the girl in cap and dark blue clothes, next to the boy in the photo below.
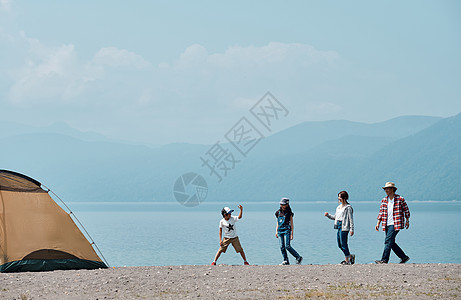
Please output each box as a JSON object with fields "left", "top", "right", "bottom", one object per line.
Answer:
{"left": 275, "top": 198, "right": 303, "bottom": 265}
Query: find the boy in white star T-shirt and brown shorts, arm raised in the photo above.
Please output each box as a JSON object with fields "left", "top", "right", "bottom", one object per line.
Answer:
{"left": 211, "top": 205, "right": 249, "bottom": 266}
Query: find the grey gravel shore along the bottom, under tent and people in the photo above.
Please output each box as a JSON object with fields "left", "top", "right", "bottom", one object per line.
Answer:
{"left": 0, "top": 264, "right": 461, "bottom": 299}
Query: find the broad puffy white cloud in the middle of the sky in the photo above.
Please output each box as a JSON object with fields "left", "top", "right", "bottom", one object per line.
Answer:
{"left": 143, "top": 42, "right": 342, "bottom": 111}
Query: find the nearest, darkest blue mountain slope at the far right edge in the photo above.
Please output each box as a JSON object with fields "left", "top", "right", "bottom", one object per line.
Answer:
{"left": 350, "top": 114, "right": 461, "bottom": 200}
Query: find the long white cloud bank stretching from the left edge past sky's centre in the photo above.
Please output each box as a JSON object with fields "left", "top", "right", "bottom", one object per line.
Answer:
{"left": 5, "top": 34, "right": 340, "bottom": 107}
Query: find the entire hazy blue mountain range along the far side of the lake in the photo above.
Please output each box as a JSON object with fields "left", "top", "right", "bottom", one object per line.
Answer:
{"left": 0, "top": 114, "right": 461, "bottom": 201}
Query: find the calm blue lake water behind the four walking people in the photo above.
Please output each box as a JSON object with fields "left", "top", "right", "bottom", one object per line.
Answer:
{"left": 68, "top": 201, "right": 461, "bottom": 267}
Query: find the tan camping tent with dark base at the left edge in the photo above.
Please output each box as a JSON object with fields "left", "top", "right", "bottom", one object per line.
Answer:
{"left": 0, "top": 170, "right": 107, "bottom": 272}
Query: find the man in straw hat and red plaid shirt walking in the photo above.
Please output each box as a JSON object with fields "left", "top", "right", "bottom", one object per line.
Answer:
{"left": 375, "top": 182, "right": 410, "bottom": 264}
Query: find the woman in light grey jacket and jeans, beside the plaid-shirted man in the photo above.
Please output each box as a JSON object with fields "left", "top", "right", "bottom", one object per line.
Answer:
{"left": 325, "top": 191, "right": 355, "bottom": 265}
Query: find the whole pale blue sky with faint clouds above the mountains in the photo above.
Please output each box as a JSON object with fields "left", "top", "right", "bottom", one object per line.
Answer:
{"left": 0, "top": 0, "right": 461, "bottom": 144}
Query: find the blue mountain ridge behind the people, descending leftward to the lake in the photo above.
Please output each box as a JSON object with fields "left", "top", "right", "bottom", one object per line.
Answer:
{"left": 214, "top": 114, "right": 461, "bottom": 200}
